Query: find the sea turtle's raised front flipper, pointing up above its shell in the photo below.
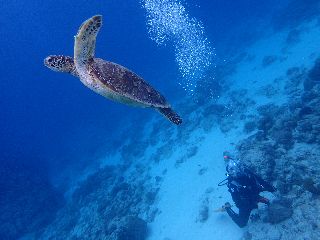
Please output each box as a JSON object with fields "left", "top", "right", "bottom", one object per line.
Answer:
{"left": 74, "top": 15, "right": 102, "bottom": 65}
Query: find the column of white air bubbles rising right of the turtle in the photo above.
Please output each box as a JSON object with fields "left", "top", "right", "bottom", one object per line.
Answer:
{"left": 142, "top": 0, "right": 214, "bottom": 91}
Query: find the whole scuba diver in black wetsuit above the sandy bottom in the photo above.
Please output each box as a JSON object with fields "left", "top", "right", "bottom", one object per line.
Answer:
{"left": 218, "top": 151, "right": 276, "bottom": 228}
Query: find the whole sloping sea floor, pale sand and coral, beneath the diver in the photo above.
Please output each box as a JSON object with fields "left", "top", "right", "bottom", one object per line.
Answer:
{"left": 29, "top": 16, "right": 320, "bottom": 240}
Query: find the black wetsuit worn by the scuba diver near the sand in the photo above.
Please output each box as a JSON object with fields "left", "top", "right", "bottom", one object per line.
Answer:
{"left": 226, "top": 168, "right": 275, "bottom": 228}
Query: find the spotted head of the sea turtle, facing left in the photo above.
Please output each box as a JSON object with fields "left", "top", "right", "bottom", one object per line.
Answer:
{"left": 44, "top": 55, "right": 78, "bottom": 76}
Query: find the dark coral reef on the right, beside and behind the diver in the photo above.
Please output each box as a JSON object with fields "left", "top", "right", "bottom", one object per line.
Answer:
{"left": 237, "top": 60, "right": 320, "bottom": 240}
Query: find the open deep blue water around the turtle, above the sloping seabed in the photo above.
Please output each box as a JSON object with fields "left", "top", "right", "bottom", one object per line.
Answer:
{"left": 0, "top": 0, "right": 319, "bottom": 239}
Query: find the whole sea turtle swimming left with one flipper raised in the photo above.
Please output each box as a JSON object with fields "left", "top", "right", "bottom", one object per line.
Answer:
{"left": 44, "top": 15, "right": 182, "bottom": 124}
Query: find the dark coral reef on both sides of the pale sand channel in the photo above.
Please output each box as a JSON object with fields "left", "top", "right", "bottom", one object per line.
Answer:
{"left": 18, "top": 46, "right": 320, "bottom": 240}
